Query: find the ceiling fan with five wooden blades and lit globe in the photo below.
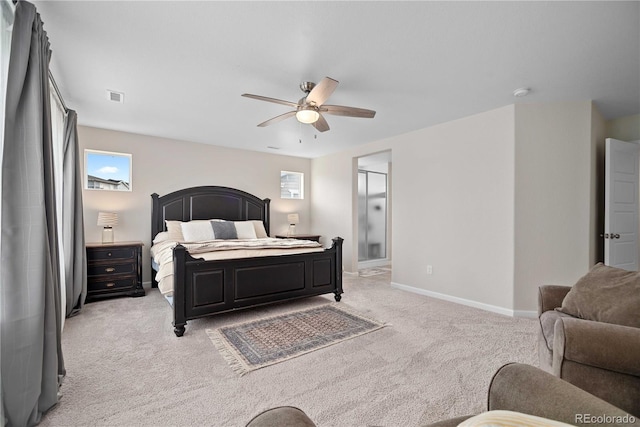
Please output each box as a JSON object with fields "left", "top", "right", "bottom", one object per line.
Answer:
{"left": 242, "top": 77, "right": 376, "bottom": 132}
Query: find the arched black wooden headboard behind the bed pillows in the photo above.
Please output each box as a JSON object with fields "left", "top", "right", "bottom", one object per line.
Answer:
{"left": 151, "top": 186, "right": 271, "bottom": 239}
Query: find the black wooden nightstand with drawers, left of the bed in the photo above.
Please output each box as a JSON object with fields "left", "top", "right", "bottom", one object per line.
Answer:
{"left": 86, "top": 242, "right": 145, "bottom": 301}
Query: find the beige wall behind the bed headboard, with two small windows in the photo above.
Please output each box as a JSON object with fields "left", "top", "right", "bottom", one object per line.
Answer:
{"left": 78, "top": 126, "right": 312, "bottom": 282}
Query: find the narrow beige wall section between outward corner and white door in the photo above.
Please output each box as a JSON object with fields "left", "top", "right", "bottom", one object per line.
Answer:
{"left": 514, "top": 102, "right": 595, "bottom": 311}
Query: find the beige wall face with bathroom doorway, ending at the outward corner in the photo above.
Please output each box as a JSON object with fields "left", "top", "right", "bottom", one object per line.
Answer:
{"left": 311, "top": 106, "right": 514, "bottom": 307}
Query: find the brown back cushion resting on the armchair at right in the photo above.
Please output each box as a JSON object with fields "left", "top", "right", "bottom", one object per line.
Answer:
{"left": 556, "top": 263, "right": 640, "bottom": 328}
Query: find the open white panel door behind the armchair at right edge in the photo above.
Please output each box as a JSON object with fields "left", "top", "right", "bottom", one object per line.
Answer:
{"left": 603, "top": 138, "right": 640, "bottom": 271}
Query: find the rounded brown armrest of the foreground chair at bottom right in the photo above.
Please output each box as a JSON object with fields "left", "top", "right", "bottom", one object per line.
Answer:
{"left": 487, "top": 363, "right": 635, "bottom": 426}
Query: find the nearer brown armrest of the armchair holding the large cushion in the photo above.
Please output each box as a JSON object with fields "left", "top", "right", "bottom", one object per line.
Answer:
{"left": 553, "top": 317, "right": 640, "bottom": 378}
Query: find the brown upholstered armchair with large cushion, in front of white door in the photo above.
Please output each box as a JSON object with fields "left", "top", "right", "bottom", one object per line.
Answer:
{"left": 538, "top": 264, "right": 640, "bottom": 417}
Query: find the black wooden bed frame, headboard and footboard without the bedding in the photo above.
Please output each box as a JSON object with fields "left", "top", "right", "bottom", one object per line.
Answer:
{"left": 151, "top": 186, "right": 343, "bottom": 337}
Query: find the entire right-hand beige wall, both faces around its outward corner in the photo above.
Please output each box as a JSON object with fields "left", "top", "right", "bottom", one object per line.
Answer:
{"left": 311, "top": 101, "right": 604, "bottom": 314}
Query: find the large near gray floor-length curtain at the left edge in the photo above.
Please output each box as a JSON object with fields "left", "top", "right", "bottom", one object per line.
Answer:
{"left": 0, "top": 1, "right": 65, "bottom": 427}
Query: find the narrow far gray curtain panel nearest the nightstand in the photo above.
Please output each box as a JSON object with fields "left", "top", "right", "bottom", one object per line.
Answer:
{"left": 62, "top": 110, "right": 87, "bottom": 316}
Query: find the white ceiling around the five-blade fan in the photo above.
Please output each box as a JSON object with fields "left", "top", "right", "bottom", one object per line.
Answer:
{"left": 34, "top": 1, "right": 640, "bottom": 158}
